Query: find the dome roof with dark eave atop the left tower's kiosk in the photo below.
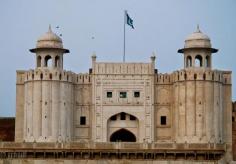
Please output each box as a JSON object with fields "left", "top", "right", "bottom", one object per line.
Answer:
{"left": 30, "top": 26, "right": 69, "bottom": 53}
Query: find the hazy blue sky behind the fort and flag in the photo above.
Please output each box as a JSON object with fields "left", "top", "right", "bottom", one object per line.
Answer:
{"left": 0, "top": 0, "right": 236, "bottom": 117}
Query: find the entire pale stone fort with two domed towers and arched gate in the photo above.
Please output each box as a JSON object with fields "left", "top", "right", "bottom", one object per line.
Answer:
{"left": 0, "top": 27, "right": 235, "bottom": 163}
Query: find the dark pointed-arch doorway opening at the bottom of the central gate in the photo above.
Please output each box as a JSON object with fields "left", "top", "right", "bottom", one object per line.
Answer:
{"left": 110, "top": 129, "right": 136, "bottom": 142}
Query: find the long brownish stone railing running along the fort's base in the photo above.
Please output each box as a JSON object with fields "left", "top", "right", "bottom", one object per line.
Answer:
{"left": 0, "top": 142, "right": 226, "bottom": 160}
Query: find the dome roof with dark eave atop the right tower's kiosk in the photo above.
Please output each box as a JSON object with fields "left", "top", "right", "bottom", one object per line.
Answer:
{"left": 178, "top": 26, "right": 218, "bottom": 53}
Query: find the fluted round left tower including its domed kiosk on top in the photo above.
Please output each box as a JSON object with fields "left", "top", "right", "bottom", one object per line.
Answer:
{"left": 23, "top": 26, "right": 73, "bottom": 142}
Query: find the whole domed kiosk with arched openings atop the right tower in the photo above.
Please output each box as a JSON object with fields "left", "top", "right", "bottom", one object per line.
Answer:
{"left": 178, "top": 26, "right": 218, "bottom": 69}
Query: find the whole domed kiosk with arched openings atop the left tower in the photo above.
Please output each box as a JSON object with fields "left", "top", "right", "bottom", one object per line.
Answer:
{"left": 30, "top": 25, "right": 69, "bottom": 69}
